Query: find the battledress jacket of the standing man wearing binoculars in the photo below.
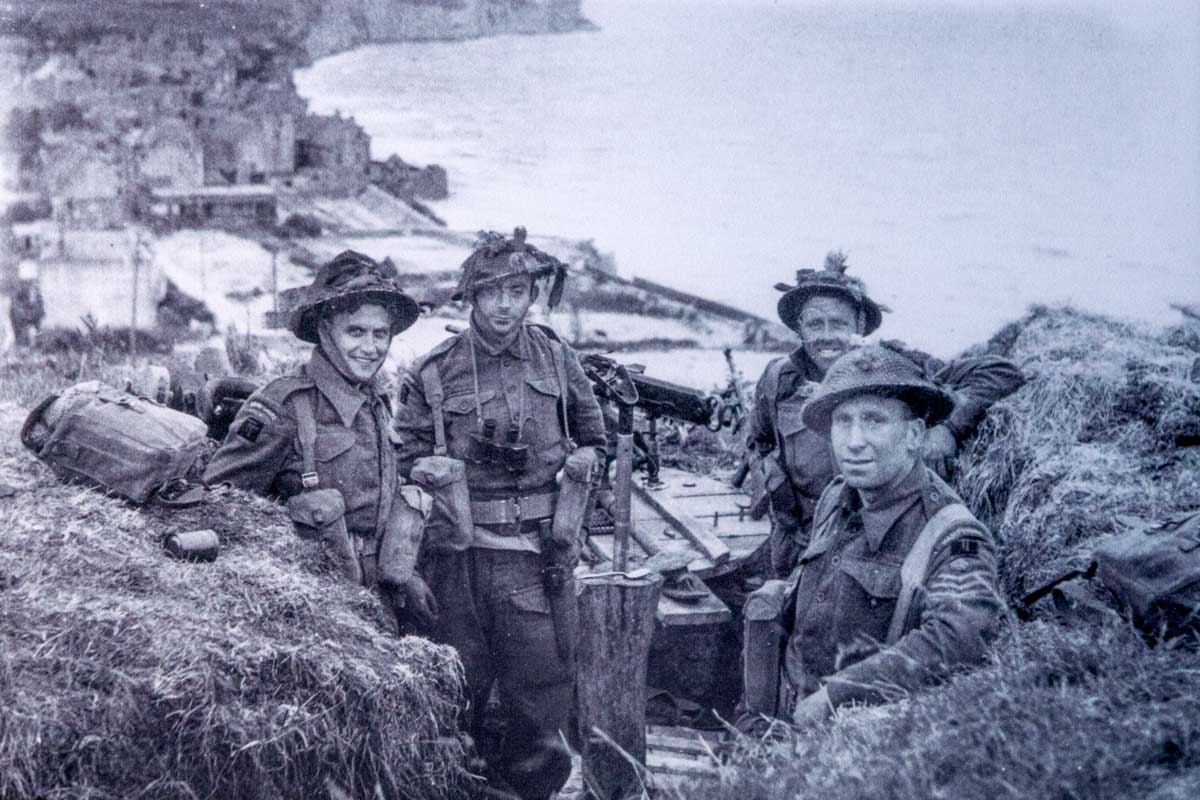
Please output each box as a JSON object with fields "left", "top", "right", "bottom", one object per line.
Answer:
{"left": 394, "top": 324, "right": 606, "bottom": 553}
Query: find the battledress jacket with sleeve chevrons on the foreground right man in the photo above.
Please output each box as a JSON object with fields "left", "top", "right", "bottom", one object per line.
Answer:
{"left": 784, "top": 462, "right": 1003, "bottom": 706}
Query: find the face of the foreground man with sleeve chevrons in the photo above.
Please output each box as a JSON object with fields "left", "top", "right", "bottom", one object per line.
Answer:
{"left": 829, "top": 395, "right": 925, "bottom": 493}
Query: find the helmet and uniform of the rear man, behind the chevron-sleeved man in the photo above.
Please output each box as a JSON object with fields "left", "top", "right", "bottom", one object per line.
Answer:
{"left": 749, "top": 254, "right": 1025, "bottom": 577}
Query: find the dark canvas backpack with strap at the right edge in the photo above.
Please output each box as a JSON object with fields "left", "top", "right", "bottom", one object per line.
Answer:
{"left": 1018, "top": 511, "right": 1200, "bottom": 639}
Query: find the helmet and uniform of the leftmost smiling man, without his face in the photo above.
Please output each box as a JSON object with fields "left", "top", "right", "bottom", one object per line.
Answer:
{"left": 205, "top": 251, "right": 420, "bottom": 587}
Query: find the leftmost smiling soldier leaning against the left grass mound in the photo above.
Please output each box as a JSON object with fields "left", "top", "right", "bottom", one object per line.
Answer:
{"left": 204, "top": 251, "right": 436, "bottom": 619}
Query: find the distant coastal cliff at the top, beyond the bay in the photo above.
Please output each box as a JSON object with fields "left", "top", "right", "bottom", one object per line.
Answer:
{"left": 297, "top": 0, "right": 592, "bottom": 59}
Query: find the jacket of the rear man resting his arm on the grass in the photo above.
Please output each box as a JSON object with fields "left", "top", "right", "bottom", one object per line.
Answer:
{"left": 749, "top": 348, "right": 1025, "bottom": 547}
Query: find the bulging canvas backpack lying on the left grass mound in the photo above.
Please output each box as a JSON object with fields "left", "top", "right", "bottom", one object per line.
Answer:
{"left": 20, "top": 380, "right": 209, "bottom": 504}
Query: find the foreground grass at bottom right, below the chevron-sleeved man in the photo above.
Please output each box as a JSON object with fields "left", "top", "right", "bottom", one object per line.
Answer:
{"left": 667, "top": 622, "right": 1200, "bottom": 800}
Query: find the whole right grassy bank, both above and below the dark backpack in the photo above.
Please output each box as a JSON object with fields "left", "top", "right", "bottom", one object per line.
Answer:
{"left": 672, "top": 308, "right": 1200, "bottom": 800}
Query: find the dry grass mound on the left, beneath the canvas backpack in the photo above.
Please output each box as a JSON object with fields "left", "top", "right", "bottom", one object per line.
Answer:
{"left": 0, "top": 398, "right": 462, "bottom": 798}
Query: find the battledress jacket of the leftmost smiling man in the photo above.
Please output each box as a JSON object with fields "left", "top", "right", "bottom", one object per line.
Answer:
{"left": 204, "top": 349, "right": 397, "bottom": 540}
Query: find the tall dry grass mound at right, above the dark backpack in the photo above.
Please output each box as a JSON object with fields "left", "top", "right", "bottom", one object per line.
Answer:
{"left": 959, "top": 308, "right": 1200, "bottom": 596}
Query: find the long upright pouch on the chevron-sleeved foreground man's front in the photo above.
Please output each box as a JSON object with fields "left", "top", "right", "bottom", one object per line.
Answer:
{"left": 742, "top": 581, "right": 796, "bottom": 716}
